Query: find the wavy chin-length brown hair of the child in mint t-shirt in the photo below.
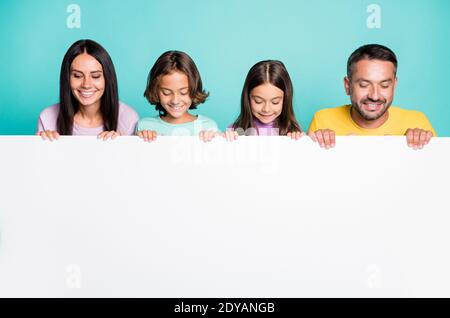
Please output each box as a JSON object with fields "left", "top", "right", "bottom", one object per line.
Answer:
{"left": 144, "top": 51, "right": 209, "bottom": 116}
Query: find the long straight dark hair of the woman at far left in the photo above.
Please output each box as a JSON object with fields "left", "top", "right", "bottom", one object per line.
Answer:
{"left": 57, "top": 40, "right": 119, "bottom": 135}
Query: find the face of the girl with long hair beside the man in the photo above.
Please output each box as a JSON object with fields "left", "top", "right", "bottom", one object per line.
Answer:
{"left": 250, "top": 83, "right": 284, "bottom": 124}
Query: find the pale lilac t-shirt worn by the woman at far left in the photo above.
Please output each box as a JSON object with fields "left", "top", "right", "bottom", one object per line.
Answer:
{"left": 37, "top": 103, "right": 139, "bottom": 136}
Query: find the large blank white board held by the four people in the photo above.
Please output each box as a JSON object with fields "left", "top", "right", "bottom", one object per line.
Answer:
{"left": 0, "top": 137, "right": 450, "bottom": 297}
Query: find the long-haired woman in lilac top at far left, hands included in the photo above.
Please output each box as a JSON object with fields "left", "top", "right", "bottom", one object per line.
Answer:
{"left": 36, "top": 40, "right": 139, "bottom": 140}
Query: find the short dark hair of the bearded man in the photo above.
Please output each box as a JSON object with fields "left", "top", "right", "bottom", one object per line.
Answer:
{"left": 347, "top": 44, "right": 397, "bottom": 78}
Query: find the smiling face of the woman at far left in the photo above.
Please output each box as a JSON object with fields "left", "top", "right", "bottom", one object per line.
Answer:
{"left": 70, "top": 53, "right": 105, "bottom": 107}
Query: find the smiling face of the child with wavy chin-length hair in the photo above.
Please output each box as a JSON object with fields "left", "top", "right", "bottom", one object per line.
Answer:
{"left": 158, "top": 71, "right": 192, "bottom": 123}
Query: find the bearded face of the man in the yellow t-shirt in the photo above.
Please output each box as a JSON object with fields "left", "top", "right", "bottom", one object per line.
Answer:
{"left": 344, "top": 59, "right": 397, "bottom": 122}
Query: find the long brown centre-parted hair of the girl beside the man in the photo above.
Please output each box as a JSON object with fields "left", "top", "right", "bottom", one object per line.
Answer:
{"left": 233, "top": 60, "right": 302, "bottom": 135}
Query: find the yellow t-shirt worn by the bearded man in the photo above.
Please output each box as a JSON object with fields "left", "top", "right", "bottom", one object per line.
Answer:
{"left": 308, "top": 105, "right": 436, "bottom": 137}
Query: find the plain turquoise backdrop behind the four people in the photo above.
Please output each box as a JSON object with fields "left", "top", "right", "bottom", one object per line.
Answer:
{"left": 0, "top": 0, "right": 450, "bottom": 136}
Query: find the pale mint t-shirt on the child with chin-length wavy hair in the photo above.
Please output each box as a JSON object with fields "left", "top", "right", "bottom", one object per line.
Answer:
{"left": 136, "top": 115, "right": 219, "bottom": 136}
